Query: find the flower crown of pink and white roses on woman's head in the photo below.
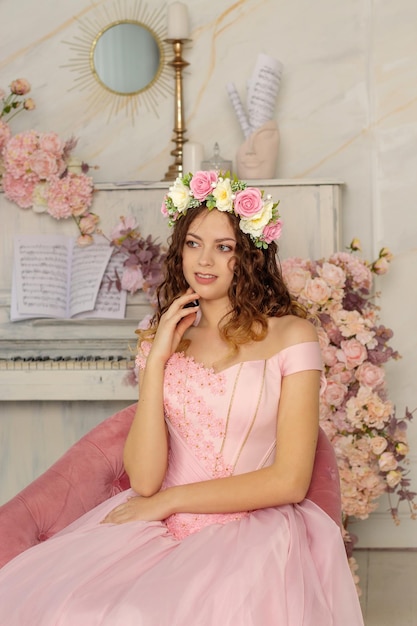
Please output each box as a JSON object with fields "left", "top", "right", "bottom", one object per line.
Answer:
{"left": 161, "top": 171, "right": 282, "bottom": 248}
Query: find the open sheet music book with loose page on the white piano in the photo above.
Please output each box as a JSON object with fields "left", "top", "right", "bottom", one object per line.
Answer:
{"left": 10, "top": 235, "right": 126, "bottom": 322}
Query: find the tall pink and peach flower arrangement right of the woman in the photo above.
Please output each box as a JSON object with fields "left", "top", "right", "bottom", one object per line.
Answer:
{"left": 282, "top": 240, "right": 417, "bottom": 557}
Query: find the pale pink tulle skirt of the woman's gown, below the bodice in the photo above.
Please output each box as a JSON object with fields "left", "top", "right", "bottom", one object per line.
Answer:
{"left": 0, "top": 491, "right": 363, "bottom": 626}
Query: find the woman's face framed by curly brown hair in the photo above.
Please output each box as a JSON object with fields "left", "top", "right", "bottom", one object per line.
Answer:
{"left": 182, "top": 209, "right": 236, "bottom": 300}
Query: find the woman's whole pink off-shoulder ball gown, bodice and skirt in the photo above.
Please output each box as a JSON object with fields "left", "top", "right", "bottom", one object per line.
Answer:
{"left": 0, "top": 342, "right": 363, "bottom": 626}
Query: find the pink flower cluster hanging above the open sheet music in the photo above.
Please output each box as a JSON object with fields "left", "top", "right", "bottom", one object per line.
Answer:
{"left": 1, "top": 130, "right": 99, "bottom": 245}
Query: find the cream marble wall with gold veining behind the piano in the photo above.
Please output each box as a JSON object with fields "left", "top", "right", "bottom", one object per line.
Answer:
{"left": 0, "top": 0, "right": 417, "bottom": 545}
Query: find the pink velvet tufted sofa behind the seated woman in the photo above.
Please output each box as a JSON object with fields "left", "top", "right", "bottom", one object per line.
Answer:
{"left": 0, "top": 404, "right": 341, "bottom": 567}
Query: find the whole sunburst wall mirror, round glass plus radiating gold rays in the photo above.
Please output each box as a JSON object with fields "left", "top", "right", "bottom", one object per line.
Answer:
{"left": 63, "top": 0, "right": 172, "bottom": 124}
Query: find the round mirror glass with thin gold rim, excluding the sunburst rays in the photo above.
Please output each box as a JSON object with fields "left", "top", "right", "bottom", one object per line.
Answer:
{"left": 90, "top": 20, "right": 163, "bottom": 95}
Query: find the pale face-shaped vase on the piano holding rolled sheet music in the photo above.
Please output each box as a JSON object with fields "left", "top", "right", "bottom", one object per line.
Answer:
{"left": 236, "top": 120, "right": 279, "bottom": 179}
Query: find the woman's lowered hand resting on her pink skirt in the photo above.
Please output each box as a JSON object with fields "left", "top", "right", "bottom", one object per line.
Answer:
{"left": 101, "top": 492, "right": 171, "bottom": 524}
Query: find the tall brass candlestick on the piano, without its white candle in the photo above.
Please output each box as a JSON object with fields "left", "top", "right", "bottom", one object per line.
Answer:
{"left": 163, "top": 39, "right": 189, "bottom": 180}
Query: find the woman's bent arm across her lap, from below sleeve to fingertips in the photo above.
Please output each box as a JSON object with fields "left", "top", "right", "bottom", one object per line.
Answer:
{"left": 106, "top": 370, "right": 320, "bottom": 523}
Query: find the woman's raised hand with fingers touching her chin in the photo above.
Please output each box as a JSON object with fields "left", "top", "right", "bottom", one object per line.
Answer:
{"left": 148, "top": 288, "right": 199, "bottom": 362}
